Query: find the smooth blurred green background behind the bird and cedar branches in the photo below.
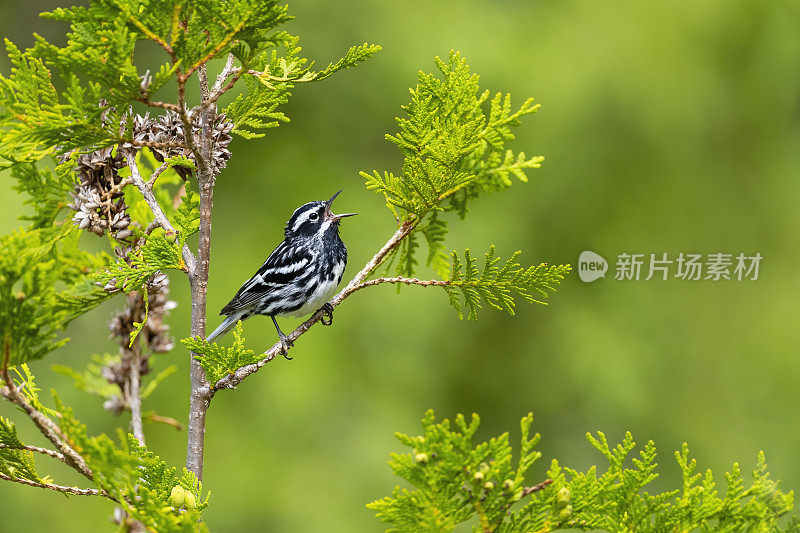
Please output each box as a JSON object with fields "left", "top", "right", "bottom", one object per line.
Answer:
{"left": 0, "top": 0, "right": 800, "bottom": 532}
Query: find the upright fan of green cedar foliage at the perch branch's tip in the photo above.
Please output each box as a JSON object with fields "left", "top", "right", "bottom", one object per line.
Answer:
{"left": 362, "top": 52, "right": 544, "bottom": 220}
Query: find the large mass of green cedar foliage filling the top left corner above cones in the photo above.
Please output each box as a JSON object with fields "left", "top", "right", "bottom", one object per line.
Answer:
{"left": 0, "top": 0, "right": 380, "bottom": 167}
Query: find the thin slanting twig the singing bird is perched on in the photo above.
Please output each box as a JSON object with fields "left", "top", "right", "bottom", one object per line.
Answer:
{"left": 202, "top": 218, "right": 418, "bottom": 397}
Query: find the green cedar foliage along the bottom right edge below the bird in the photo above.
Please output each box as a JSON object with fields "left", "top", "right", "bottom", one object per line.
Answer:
{"left": 368, "top": 411, "right": 800, "bottom": 533}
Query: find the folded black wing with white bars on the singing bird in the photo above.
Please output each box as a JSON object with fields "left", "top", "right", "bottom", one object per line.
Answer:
{"left": 220, "top": 241, "right": 313, "bottom": 315}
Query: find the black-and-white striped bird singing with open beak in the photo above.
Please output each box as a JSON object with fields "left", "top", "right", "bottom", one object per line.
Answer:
{"left": 206, "top": 191, "right": 356, "bottom": 359}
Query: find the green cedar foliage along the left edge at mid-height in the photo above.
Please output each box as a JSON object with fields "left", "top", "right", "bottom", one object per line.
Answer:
{"left": 0, "top": 163, "right": 110, "bottom": 366}
